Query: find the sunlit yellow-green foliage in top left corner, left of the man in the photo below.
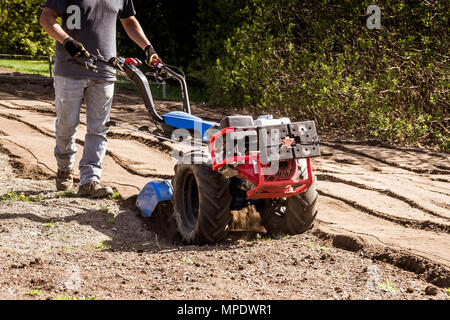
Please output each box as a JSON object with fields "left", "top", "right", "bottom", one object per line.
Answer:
{"left": 0, "top": 0, "right": 54, "bottom": 55}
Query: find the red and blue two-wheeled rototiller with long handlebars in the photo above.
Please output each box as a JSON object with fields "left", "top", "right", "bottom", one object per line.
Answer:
{"left": 74, "top": 55, "right": 320, "bottom": 244}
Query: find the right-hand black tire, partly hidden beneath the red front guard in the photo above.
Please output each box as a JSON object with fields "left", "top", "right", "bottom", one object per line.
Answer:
{"left": 260, "top": 182, "right": 319, "bottom": 235}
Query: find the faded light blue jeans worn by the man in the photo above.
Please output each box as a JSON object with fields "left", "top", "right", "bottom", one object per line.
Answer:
{"left": 54, "top": 76, "right": 114, "bottom": 185}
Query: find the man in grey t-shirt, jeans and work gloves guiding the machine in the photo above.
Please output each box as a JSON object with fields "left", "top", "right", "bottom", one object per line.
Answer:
{"left": 40, "top": 0, "right": 158, "bottom": 198}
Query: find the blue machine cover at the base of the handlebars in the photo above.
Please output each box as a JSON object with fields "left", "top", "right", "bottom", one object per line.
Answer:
{"left": 163, "top": 111, "right": 219, "bottom": 141}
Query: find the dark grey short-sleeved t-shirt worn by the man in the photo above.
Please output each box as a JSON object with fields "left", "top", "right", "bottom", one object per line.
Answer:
{"left": 44, "top": 0, "right": 136, "bottom": 81}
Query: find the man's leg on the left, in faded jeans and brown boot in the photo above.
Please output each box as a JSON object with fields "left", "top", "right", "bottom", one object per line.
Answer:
{"left": 54, "top": 76, "right": 87, "bottom": 191}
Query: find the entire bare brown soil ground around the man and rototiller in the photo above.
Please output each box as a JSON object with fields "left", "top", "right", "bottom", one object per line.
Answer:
{"left": 0, "top": 70, "right": 450, "bottom": 299}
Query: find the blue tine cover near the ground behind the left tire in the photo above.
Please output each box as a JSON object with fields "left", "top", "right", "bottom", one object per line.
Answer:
{"left": 136, "top": 180, "right": 173, "bottom": 218}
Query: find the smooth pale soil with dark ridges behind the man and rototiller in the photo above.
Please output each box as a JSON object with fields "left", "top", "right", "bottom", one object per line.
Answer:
{"left": 0, "top": 75, "right": 450, "bottom": 297}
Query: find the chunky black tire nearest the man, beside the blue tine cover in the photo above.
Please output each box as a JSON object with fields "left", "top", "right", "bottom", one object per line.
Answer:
{"left": 172, "top": 154, "right": 232, "bottom": 244}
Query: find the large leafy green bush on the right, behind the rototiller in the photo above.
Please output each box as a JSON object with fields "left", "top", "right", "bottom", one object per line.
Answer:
{"left": 204, "top": 0, "right": 450, "bottom": 150}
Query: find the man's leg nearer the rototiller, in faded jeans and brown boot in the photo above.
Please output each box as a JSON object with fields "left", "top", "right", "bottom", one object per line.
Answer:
{"left": 80, "top": 80, "right": 114, "bottom": 197}
